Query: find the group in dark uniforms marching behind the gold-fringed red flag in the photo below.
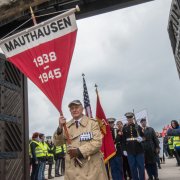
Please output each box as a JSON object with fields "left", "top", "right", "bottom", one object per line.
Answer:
{"left": 108, "top": 112, "right": 160, "bottom": 180}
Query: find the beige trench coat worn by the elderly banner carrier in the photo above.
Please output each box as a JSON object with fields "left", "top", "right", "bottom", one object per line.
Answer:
{"left": 53, "top": 116, "right": 108, "bottom": 180}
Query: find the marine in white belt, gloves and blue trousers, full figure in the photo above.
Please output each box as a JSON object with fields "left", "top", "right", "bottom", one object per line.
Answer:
{"left": 123, "top": 112, "right": 145, "bottom": 180}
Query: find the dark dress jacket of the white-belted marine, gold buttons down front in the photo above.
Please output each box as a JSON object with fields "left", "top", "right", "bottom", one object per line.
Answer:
{"left": 123, "top": 124, "right": 144, "bottom": 154}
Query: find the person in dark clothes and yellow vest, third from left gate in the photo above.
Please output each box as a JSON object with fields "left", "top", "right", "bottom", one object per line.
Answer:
{"left": 46, "top": 140, "right": 54, "bottom": 179}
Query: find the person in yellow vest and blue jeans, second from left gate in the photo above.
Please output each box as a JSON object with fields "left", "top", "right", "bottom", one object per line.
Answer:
{"left": 38, "top": 133, "right": 48, "bottom": 180}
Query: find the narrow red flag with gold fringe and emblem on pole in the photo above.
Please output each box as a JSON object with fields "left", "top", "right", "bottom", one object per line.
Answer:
{"left": 96, "top": 92, "right": 116, "bottom": 163}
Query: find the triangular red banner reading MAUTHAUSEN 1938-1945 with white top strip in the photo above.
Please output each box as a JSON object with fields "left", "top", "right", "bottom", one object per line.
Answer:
{"left": 0, "top": 9, "right": 77, "bottom": 111}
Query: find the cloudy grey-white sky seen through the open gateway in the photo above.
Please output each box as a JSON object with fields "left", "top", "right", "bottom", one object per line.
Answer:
{"left": 28, "top": 0, "right": 180, "bottom": 136}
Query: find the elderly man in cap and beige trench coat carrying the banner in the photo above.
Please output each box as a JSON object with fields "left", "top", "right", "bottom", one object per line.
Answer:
{"left": 56, "top": 100, "right": 108, "bottom": 180}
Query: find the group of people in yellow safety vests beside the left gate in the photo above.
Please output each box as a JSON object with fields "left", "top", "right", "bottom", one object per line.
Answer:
{"left": 29, "top": 132, "right": 67, "bottom": 180}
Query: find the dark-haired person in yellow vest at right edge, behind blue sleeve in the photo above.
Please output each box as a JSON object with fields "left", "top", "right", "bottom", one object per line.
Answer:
{"left": 171, "top": 120, "right": 180, "bottom": 166}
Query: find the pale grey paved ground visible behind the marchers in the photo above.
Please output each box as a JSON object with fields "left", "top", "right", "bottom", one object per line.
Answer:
{"left": 45, "top": 158, "right": 180, "bottom": 180}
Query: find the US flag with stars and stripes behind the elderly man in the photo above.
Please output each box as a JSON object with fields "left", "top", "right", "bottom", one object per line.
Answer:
{"left": 82, "top": 74, "right": 92, "bottom": 118}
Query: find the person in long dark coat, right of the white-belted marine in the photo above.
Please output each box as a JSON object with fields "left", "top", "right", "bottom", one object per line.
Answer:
{"left": 140, "top": 118, "right": 160, "bottom": 180}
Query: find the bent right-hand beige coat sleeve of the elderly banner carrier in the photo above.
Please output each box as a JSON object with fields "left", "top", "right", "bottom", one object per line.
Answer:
{"left": 79, "top": 120, "right": 102, "bottom": 158}
